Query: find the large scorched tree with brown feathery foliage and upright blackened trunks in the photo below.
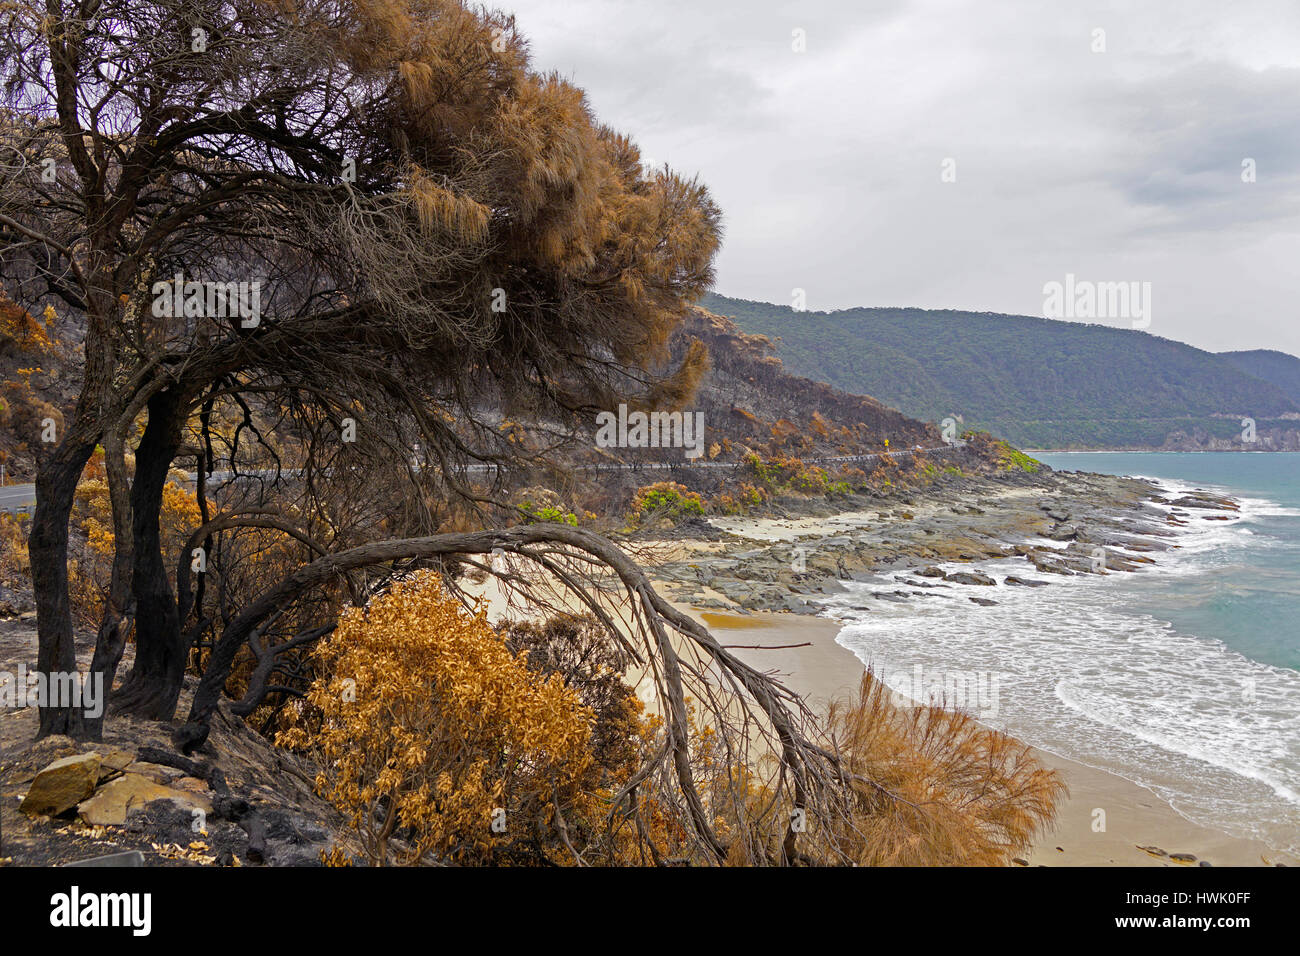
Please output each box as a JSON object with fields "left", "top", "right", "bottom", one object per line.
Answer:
{"left": 0, "top": 0, "right": 719, "bottom": 731}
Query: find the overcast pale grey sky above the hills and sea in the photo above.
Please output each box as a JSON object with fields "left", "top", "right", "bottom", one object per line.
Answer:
{"left": 495, "top": 0, "right": 1300, "bottom": 354}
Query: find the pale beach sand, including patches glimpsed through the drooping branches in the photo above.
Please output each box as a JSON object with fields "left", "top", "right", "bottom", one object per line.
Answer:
{"left": 465, "top": 470, "right": 1300, "bottom": 866}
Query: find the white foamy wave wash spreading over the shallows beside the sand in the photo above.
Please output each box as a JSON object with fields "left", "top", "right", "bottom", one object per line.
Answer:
{"left": 828, "top": 538, "right": 1300, "bottom": 849}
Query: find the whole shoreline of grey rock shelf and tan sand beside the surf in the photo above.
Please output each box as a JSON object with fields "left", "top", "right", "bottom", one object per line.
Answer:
{"left": 654, "top": 471, "right": 1300, "bottom": 866}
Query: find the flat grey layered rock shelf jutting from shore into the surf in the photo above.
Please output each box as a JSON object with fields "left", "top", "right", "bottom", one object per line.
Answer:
{"left": 655, "top": 473, "right": 1236, "bottom": 614}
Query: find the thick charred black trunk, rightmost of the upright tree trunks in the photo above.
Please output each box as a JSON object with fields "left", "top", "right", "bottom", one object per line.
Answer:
{"left": 112, "top": 392, "right": 189, "bottom": 721}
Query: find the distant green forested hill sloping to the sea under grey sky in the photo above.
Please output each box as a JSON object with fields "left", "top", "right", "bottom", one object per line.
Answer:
{"left": 701, "top": 295, "right": 1300, "bottom": 447}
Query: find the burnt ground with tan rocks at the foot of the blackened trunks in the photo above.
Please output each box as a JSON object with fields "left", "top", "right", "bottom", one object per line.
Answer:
{"left": 0, "top": 650, "right": 356, "bottom": 866}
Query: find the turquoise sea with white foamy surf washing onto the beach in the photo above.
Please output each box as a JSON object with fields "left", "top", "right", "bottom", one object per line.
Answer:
{"left": 828, "top": 453, "right": 1300, "bottom": 853}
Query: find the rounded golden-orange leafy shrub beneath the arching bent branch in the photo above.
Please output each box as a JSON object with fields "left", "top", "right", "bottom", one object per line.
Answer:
{"left": 277, "top": 572, "right": 594, "bottom": 865}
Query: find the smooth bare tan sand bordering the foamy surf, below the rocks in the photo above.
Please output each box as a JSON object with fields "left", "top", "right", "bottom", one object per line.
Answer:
{"left": 683, "top": 606, "right": 1300, "bottom": 866}
